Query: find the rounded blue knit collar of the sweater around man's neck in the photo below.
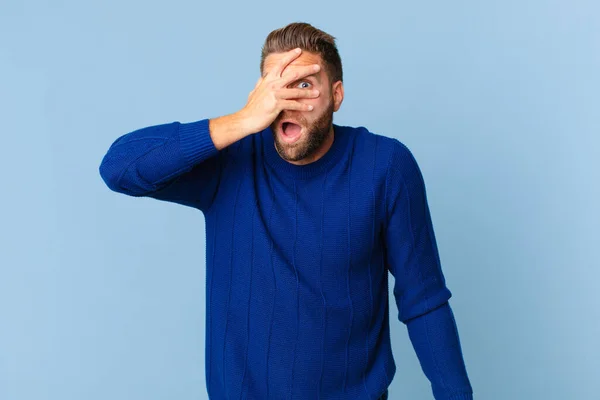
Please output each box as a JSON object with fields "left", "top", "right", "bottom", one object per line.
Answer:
{"left": 262, "top": 124, "right": 350, "bottom": 179}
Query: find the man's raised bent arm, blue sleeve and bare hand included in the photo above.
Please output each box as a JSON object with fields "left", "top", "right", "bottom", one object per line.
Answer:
{"left": 99, "top": 49, "right": 320, "bottom": 211}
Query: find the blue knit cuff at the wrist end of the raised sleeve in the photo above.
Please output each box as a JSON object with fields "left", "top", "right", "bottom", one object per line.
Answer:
{"left": 179, "top": 119, "right": 219, "bottom": 165}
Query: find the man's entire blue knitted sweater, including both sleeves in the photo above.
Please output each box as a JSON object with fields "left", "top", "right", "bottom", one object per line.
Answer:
{"left": 100, "top": 119, "right": 472, "bottom": 400}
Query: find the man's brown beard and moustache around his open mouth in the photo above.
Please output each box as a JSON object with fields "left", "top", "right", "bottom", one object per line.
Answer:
{"left": 271, "top": 99, "right": 333, "bottom": 161}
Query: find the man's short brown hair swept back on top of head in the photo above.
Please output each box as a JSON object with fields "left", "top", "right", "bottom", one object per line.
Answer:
{"left": 260, "top": 22, "right": 343, "bottom": 83}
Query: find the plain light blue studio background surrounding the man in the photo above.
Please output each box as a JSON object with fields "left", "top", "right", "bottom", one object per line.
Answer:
{"left": 0, "top": 0, "right": 600, "bottom": 400}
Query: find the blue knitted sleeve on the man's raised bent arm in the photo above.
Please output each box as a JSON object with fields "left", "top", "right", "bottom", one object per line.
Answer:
{"left": 99, "top": 119, "right": 228, "bottom": 211}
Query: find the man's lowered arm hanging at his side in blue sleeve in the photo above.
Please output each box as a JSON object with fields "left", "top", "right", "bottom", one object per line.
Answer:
{"left": 385, "top": 141, "right": 473, "bottom": 400}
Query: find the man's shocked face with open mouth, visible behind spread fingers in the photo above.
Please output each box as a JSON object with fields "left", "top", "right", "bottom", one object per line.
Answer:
{"left": 263, "top": 51, "right": 341, "bottom": 164}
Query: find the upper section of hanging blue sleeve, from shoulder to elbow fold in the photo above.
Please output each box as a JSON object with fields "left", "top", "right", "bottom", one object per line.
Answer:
{"left": 385, "top": 140, "right": 452, "bottom": 324}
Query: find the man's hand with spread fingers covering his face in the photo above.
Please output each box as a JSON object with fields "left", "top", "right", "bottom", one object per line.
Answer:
{"left": 239, "top": 49, "right": 320, "bottom": 133}
